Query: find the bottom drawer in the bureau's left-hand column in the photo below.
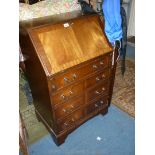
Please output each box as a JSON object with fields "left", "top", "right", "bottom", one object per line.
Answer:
{"left": 58, "top": 107, "right": 85, "bottom": 132}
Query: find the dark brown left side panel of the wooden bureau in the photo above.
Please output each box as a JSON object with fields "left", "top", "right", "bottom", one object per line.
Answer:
{"left": 20, "top": 34, "right": 54, "bottom": 128}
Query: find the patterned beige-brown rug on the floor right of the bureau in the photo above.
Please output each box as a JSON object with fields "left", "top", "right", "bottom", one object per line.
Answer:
{"left": 112, "top": 60, "right": 135, "bottom": 117}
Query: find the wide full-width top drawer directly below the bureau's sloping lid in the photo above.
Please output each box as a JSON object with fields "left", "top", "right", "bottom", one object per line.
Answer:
{"left": 50, "top": 55, "right": 110, "bottom": 92}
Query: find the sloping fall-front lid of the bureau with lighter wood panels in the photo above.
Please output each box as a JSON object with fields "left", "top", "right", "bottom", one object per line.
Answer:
{"left": 29, "top": 15, "right": 112, "bottom": 75}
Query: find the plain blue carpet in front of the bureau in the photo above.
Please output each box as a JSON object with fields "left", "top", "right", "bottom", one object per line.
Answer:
{"left": 20, "top": 105, "right": 135, "bottom": 155}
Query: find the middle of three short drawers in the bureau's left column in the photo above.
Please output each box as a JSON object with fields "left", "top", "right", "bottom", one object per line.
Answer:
{"left": 55, "top": 96, "right": 84, "bottom": 120}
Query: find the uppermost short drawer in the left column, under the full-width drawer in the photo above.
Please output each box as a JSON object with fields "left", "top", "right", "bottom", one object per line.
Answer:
{"left": 51, "top": 82, "right": 84, "bottom": 105}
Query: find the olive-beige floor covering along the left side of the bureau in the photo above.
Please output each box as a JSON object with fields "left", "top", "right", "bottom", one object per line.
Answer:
{"left": 19, "top": 72, "right": 48, "bottom": 145}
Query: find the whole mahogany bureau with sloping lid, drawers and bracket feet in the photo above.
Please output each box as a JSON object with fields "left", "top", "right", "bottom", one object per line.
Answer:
{"left": 25, "top": 15, "right": 116, "bottom": 145}
